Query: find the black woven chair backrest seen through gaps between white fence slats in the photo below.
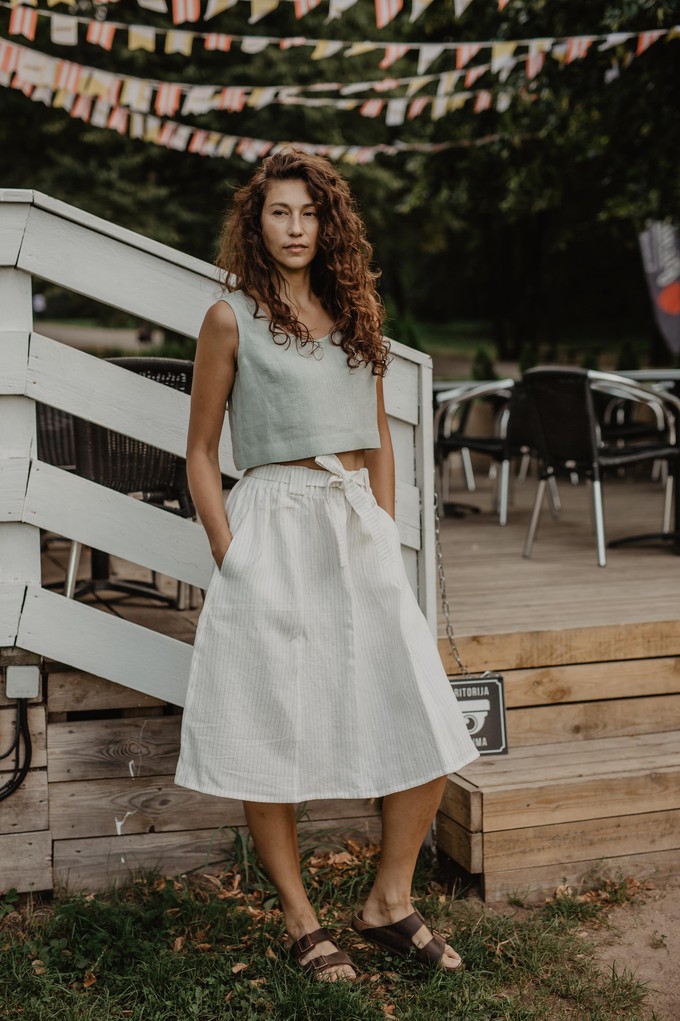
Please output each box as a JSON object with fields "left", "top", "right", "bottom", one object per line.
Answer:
{"left": 74, "top": 356, "right": 194, "bottom": 509}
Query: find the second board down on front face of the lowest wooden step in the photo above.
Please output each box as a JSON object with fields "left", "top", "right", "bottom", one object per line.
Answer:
{"left": 479, "top": 809, "right": 680, "bottom": 872}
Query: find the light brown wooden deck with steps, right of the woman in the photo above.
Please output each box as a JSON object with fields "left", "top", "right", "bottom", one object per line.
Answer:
{"left": 430, "top": 463, "right": 680, "bottom": 900}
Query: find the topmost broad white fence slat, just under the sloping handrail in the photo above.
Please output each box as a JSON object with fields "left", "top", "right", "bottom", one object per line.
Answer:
{"left": 17, "top": 206, "right": 221, "bottom": 337}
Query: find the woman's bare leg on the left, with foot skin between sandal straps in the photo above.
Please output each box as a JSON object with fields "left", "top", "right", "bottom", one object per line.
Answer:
{"left": 243, "top": 801, "right": 355, "bottom": 980}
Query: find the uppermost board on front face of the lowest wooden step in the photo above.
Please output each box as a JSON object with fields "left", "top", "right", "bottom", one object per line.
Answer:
{"left": 484, "top": 764, "right": 680, "bottom": 834}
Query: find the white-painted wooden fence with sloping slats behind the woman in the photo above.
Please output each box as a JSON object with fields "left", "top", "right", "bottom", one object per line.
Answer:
{"left": 0, "top": 190, "right": 436, "bottom": 706}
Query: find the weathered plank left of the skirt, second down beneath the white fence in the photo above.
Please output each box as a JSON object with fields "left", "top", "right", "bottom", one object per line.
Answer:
{"left": 48, "top": 716, "right": 182, "bottom": 783}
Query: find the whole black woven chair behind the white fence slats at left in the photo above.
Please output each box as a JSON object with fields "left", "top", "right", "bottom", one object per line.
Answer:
{"left": 64, "top": 356, "right": 196, "bottom": 610}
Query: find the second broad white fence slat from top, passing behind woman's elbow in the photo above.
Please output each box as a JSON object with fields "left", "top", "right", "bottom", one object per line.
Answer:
{"left": 27, "top": 333, "right": 242, "bottom": 478}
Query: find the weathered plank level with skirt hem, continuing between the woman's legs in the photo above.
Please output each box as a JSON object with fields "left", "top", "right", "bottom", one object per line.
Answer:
{"left": 49, "top": 776, "right": 379, "bottom": 839}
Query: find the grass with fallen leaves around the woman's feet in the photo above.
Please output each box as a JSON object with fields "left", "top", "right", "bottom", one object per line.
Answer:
{"left": 0, "top": 841, "right": 645, "bottom": 1021}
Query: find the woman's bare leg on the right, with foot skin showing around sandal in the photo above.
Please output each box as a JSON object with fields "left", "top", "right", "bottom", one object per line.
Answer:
{"left": 361, "top": 776, "right": 460, "bottom": 968}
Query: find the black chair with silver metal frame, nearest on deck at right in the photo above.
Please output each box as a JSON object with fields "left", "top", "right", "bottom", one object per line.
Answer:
{"left": 523, "top": 368, "right": 680, "bottom": 567}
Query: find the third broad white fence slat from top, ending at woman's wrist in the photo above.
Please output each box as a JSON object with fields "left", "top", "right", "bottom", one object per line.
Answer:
{"left": 23, "top": 460, "right": 214, "bottom": 588}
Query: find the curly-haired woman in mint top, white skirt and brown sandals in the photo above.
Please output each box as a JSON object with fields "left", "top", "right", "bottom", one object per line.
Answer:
{"left": 176, "top": 150, "right": 477, "bottom": 980}
